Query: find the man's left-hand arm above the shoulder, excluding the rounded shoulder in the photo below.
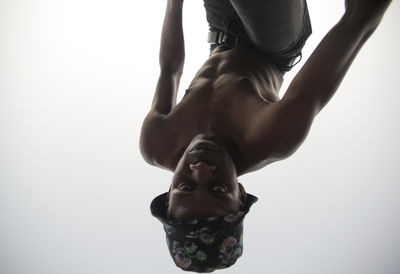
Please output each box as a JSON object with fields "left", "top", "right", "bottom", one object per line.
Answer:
{"left": 151, "top": 0, "right": 185, "bottom": 114}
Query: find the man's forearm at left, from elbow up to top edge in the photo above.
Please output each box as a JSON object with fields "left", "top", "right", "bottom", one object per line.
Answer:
{"left": 160, "top": 0, "right": 185, "bottom": 75}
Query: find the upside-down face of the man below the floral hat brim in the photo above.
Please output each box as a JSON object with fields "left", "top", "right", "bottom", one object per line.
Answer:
{"left": 168, "top": 135, "right": 244, "bottom": 219}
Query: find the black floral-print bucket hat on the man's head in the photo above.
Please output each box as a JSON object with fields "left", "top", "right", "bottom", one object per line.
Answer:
{"left": 150, "top": 193, "right": 258, "bottom": 272}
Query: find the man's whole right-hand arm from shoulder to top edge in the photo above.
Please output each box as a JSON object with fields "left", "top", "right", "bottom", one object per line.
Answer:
{"left": 247, "top": 0, "right": 390, "bottom": 160}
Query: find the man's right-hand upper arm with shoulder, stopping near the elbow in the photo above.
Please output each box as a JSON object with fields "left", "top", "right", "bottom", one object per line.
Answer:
{"left": 255, "top": 19, "right": 363, "bottom": 156}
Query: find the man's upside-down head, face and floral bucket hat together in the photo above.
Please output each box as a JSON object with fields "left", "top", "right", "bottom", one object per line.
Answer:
{"left": 151, "top": 135, "right": 257, "bottom": 272}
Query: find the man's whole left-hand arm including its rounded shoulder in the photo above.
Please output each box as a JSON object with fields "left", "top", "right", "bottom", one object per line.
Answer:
{"left": 140, "top": 0, "right": 185, "bottom": 166}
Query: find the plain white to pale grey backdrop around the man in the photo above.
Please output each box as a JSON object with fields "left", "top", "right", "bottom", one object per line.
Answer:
{"left": 0, "top": 0, "right": 400, "bottom": 274}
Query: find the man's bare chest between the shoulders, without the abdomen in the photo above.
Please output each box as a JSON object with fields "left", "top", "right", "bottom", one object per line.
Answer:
{"left": 159, "top": 74, "right": 272, "bottom": 169}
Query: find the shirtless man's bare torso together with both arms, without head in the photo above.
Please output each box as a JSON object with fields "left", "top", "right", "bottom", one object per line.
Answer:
{"left": 140, "top": 0, "right": 391, "bottom": 175}
